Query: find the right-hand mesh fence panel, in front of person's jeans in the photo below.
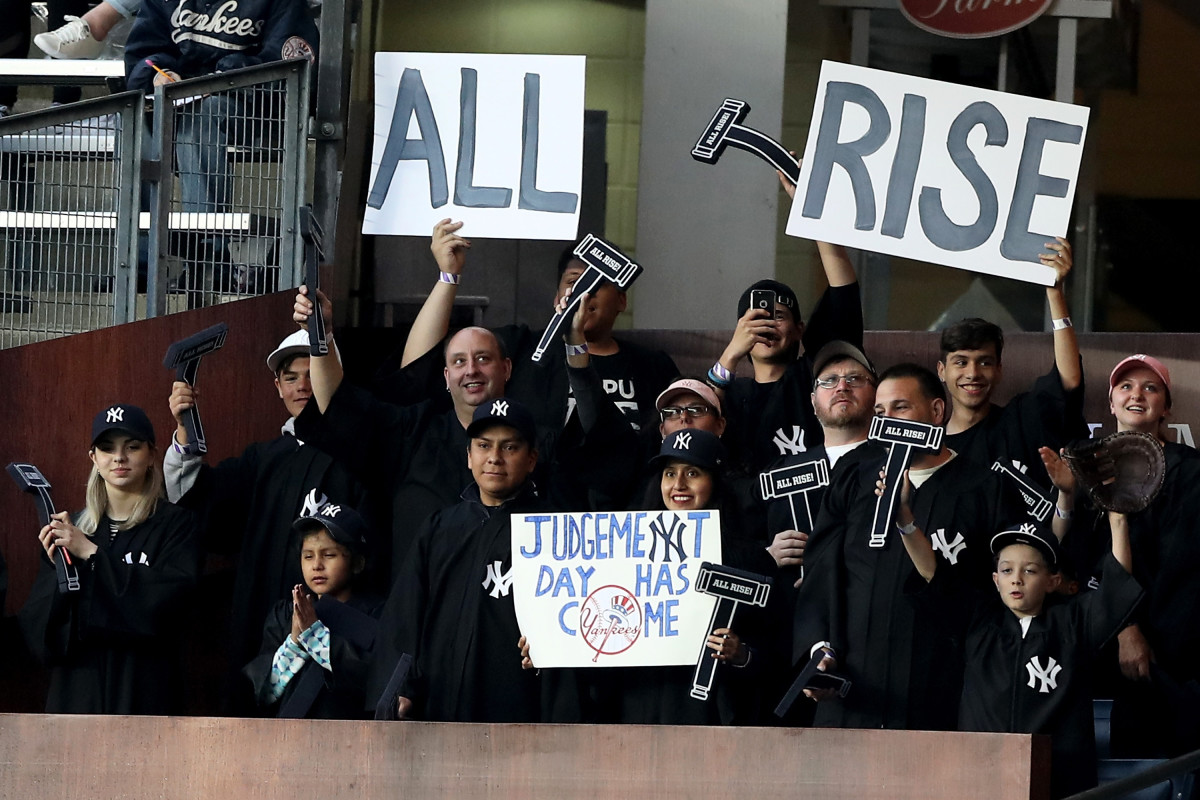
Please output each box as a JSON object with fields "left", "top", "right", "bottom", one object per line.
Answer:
{"left": 149, "top": 61, "right": 308, "bottom": 312}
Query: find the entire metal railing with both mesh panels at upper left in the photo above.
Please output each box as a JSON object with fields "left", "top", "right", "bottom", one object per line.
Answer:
{"left": 0, "top": 59, "right": 308, "bottom": 348}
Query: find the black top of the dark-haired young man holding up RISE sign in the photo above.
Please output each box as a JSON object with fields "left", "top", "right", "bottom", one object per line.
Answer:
{"left": 944, "top": 367, "right": 1090, "bottom": 521}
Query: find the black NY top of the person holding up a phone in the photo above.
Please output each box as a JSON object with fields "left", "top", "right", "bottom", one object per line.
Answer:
{"left": 722, "top": 283, "right": 863, "bottom": 474}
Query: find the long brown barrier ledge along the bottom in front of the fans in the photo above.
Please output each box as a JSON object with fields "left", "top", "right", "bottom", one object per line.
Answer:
{"left": 0, "top": 715, "right": 1049, "bottom": 800}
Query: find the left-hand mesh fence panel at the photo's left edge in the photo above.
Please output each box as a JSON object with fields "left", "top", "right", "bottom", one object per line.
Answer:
{"left": 0, "top": 92, "right": 143, "bottom": 347}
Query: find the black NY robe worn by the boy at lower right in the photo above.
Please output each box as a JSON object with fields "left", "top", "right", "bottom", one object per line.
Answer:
{"left": 919, "top": 554, "right": 1142, "bottom": 798}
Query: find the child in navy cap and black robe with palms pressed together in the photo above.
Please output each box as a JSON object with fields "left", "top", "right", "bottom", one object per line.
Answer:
{"left": 242, "top": 503, "right": 382, "bottom": 720}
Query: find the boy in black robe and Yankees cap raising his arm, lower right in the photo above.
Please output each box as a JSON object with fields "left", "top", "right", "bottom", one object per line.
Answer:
{"left": 904, "top": 513, "right": 1142, "bottom": 798}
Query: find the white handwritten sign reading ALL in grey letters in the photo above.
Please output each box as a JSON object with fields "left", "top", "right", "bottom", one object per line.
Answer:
{"left": 362, "top": 53, "right": 584, "bottom": 240}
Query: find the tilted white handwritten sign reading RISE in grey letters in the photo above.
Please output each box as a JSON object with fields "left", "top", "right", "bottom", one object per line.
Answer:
{"left": 787, "top": 61, "right": 1088, "bottom": 285}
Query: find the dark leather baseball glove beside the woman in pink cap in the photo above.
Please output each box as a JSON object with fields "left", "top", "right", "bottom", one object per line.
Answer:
{"left": 1062, "top": 431, "right": 1166, "bottom": 513}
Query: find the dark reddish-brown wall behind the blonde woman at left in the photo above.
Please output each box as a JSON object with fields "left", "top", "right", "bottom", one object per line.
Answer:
{"left": 0, "top": 291, "right": 295, "bottom": 614}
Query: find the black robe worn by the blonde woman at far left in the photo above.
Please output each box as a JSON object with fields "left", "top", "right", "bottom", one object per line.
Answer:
{"left": 20, "top": 500, "right": 200, "bottom": 715}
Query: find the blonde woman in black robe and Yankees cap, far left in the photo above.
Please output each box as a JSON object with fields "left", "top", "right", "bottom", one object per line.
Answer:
{"left": 22, "top": 403, "right": 199, "bottom": 714}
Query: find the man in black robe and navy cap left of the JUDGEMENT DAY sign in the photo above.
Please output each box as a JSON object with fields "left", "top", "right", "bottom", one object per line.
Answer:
{"left": 368, "top": 398, "right": 546, "bottom": 722}
